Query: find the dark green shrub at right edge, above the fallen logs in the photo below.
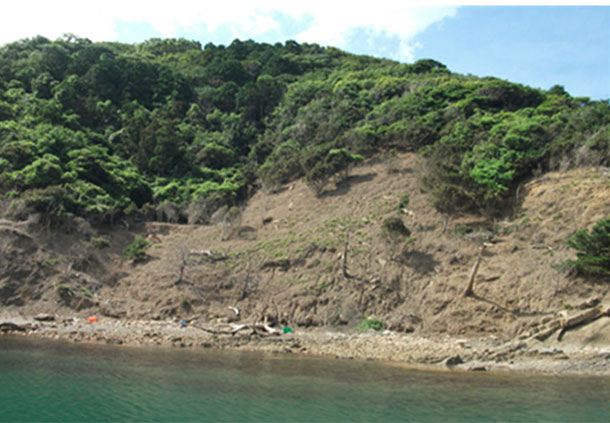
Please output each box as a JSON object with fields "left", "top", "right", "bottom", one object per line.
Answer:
{"left": 567, "top": 218, "right": 610, "bottom": 276}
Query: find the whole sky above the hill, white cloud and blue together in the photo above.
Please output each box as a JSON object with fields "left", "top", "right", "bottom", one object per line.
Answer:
{"left": 0, "top": 0, "right": 610, "bottom": 99}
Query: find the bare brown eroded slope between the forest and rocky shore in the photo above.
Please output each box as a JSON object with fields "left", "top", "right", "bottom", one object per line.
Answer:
{"left": 0, "top": 154, "right": 610, "bottom": 342}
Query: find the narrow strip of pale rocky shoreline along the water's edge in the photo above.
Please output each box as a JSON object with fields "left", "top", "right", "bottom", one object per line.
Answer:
{"left": 0, "top": 315, "right": 610, "bottom": 376}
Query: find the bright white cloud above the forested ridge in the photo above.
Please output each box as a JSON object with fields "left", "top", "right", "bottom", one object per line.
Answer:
{"left": 0, "top": 0, "right": 456, "bottom": 60}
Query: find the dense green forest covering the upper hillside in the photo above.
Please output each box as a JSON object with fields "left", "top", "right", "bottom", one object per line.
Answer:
{"left": 0, "top": 35, "right": 610, "bottom": 223}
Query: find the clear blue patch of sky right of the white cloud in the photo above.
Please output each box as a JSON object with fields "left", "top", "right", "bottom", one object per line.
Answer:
{"left": 408, "top": 6, "right": 610, "bottom": 99}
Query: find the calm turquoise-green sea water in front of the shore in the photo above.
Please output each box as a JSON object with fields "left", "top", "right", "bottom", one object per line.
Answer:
{"left": 0, "top": 337, "right": 610, "bottom": 422}
